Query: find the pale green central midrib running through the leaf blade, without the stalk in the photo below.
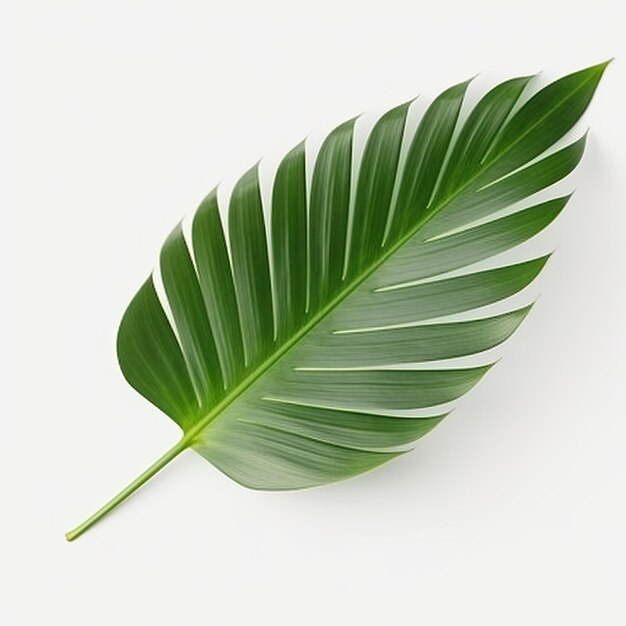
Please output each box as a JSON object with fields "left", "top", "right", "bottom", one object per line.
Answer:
{"left": 181, "top": 70, "right": 588, "bottom": 448}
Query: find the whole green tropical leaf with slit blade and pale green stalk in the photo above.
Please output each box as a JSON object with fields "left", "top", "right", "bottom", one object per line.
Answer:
{"left": 67, "top": 63, "right": 607, "bottom": 540}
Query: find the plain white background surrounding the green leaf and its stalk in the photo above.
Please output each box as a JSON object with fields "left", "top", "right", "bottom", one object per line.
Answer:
{"left": 0, "top": 0, "right": 626, "bottom": 626}
